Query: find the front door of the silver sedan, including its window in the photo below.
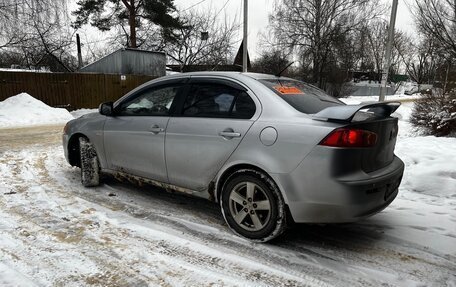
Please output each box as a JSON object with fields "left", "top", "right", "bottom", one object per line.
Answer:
{"left": 104, "top": 82, "right": 183, "bottom": 182}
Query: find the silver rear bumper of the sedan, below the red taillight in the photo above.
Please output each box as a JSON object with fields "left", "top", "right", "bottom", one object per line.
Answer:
{"left": 273, "top": 153, "right": 404, "bottom": 223}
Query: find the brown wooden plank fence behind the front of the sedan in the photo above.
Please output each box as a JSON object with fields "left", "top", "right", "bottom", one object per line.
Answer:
{"left": 0, "top": 71, "right": 154, "bottom": 110}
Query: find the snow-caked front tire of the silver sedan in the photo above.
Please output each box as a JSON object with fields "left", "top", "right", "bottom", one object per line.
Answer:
{"left": 79, "top": 137, "right": 100, "bottom": 187}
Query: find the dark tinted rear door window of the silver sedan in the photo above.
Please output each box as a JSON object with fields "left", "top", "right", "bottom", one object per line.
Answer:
{"left": 183, "top": 84, "right": 255, "bottom": 119}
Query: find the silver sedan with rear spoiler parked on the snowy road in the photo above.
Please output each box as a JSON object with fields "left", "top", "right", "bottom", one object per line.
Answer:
{"left": 63, "top": 72, "right": 404, "bottom": 242}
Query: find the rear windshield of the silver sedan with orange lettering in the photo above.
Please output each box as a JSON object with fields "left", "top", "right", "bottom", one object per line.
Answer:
{"left": 259, "top": 79, "right": 344, "bottom": 114}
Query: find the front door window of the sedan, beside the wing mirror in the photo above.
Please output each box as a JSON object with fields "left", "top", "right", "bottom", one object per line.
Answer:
{"left": 119, "top": 85, "right": 181, "bottom": 116}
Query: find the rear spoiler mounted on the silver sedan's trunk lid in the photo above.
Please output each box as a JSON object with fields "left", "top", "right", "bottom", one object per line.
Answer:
{"left": 313, "top": 102, "right": 401, "bottom": 122}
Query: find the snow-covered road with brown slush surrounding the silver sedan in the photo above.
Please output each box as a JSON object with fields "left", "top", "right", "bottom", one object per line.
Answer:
{"left": 0, "top": 126, "right": 456, "bottom": 286}
